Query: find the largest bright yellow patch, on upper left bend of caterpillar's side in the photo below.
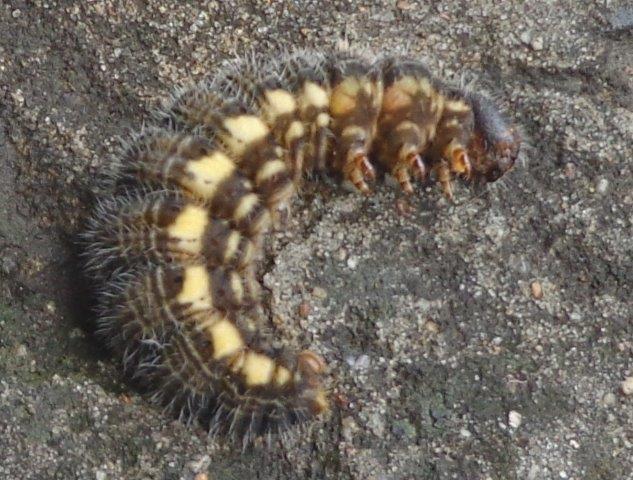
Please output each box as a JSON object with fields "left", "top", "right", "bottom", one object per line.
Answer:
{"left": 181, "top": 152, "right": 235, "bottom": 200}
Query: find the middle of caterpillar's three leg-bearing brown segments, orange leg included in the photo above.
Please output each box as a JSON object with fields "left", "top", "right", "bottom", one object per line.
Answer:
{"left": 376, "top": 59, "right": 444, "bottom": 193}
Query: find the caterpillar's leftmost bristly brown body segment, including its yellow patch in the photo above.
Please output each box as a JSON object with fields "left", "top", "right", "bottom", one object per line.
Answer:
{"left": 84, "top": 191, "right": 256, "bottom": 277}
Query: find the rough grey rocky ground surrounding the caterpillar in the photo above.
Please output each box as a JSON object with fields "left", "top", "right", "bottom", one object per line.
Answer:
{"left": 0, "top": 0, "right": 633, "bottom": 480}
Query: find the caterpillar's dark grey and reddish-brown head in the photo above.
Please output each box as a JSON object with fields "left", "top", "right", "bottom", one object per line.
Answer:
{"left": 468, "top": 94, "right": 521, "bottom": 182}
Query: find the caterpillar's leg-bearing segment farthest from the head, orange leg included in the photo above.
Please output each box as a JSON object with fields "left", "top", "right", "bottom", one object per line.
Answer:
{"left": 330, "top": 58, "right": 383, "bottom": 193}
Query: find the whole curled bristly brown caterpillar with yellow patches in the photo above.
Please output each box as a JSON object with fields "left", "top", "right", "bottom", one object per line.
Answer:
{"left": 82, "top": 50, "right": 521, "bottom": 445}
